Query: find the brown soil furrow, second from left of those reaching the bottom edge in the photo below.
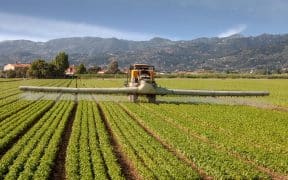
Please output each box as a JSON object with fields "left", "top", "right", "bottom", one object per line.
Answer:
{"left": 97, "top": 104, "right": 142, "bottom": 180}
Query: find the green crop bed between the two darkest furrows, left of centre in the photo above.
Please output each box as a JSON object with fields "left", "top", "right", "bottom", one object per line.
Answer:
{"left": 66, "top": 101, "right": 122, "bottom": 180}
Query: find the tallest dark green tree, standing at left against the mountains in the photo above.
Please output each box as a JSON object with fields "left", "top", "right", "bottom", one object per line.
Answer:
{"left": 52, "top": 52, "right": 69, "bottom": 76}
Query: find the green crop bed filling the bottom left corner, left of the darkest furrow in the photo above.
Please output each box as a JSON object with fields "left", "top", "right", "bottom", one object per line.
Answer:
{"left": 0, "top": 102, "right": 73, "bottom": 179}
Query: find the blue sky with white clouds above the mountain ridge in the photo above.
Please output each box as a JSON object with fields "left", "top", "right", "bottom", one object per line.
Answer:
{"left": 0, "top": 0, "right": 288, "bottom": 41}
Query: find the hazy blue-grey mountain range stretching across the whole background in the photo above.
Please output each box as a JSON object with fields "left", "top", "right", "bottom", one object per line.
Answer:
{"left": 0, "top": 34, "right": 288, "bottom": 71}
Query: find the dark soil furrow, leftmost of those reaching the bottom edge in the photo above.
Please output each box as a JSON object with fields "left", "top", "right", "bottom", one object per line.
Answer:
{"left": 50, "top": 103, "right": 77, "bottom": 180}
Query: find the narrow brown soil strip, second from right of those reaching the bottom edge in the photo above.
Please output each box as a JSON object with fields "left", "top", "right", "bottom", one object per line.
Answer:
{"left": 119, "top": 104, "right": 213, "bottom": 179}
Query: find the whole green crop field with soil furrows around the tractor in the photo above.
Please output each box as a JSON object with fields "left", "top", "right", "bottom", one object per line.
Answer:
{"left": 0, "top": 79, "right": 288, "bottom": 180}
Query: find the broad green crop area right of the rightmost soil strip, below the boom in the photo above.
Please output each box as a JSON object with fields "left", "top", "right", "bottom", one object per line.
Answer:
{"left": 143, "top": 104, "right": 288, "bottom": 173}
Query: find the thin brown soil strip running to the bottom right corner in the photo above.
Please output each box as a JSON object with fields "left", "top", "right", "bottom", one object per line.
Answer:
{"left": 141, "top": 106, "right": 288, "bottom": 179}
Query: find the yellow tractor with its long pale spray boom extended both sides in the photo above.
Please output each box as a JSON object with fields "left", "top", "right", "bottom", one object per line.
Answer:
{"left": 19, "top": 64, "right": 269, "bottom": 103}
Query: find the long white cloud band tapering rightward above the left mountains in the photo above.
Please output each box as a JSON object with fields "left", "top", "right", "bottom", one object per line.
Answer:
{"left": 0, "top": 12, "right": 157, "bottom": 41}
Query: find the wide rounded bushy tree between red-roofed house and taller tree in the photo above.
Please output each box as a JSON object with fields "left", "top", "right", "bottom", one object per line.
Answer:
{"left": 28, "top": 59, "right": 49, "bottom": 78}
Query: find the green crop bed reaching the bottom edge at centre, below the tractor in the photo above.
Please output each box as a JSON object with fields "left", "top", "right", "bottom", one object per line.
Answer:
{"left": 100, "top": 102, "right": 199, "bottom": 179}
